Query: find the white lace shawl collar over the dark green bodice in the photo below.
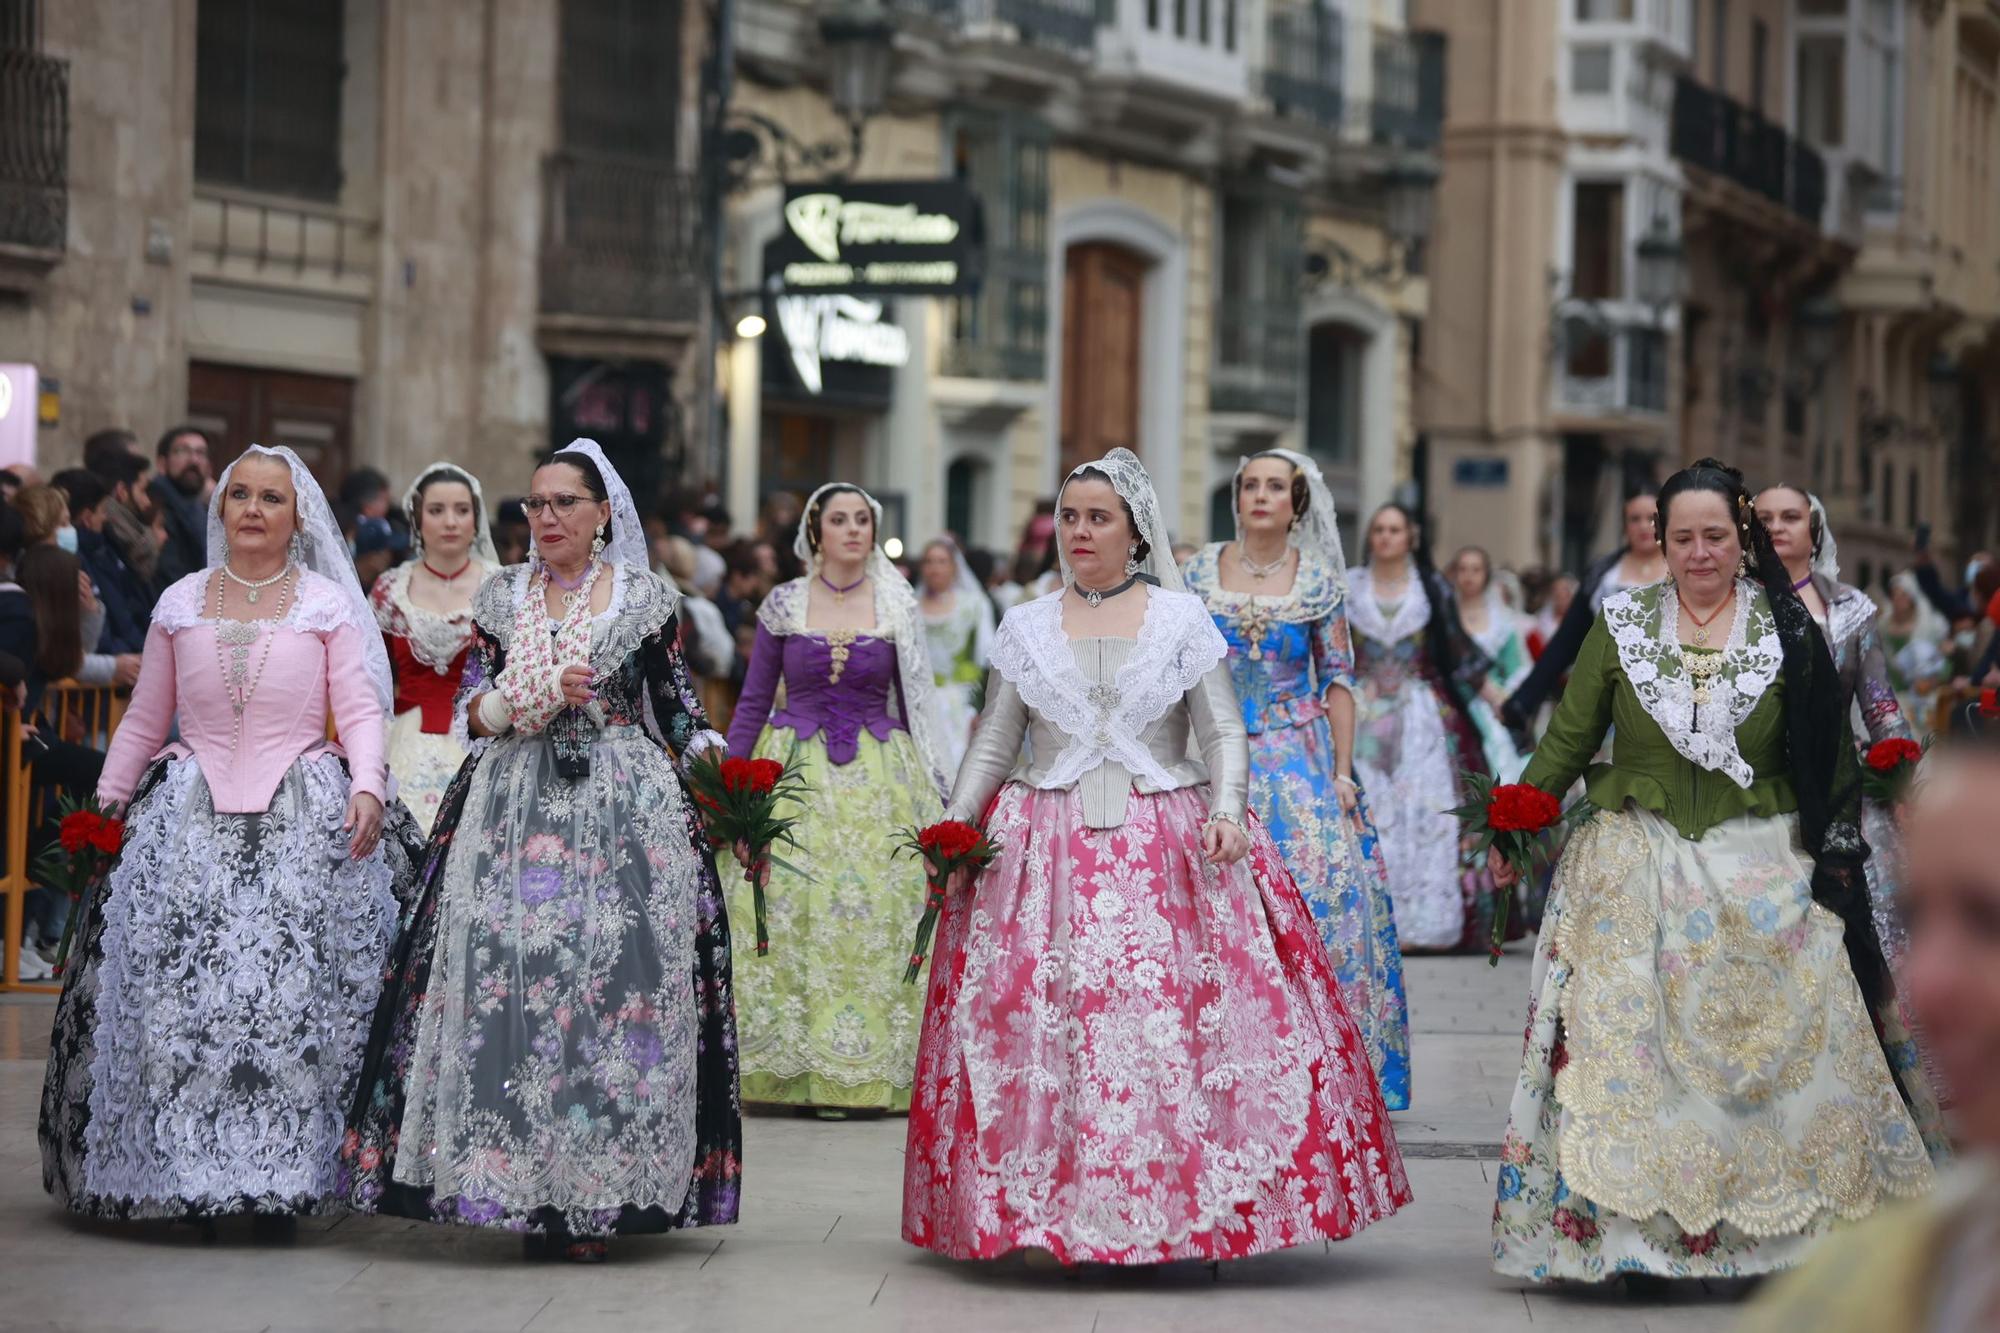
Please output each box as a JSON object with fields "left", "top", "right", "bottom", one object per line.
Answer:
{"left": 1604, "top": 578, "right": 1784, "bottom": 787}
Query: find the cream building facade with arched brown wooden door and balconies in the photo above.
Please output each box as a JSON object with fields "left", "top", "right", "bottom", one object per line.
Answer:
{"left": 720, "top": 0, "right": 1444, "bottom": 550}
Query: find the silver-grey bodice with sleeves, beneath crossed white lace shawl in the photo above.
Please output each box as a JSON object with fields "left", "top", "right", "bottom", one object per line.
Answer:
{"left": 946, "top": 638, "right": 1250, "bottom": 829}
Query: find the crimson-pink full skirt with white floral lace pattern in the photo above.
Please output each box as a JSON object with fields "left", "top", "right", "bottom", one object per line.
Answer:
{"left": 902, "top": 783, "right": 1410, "bottom": 1263}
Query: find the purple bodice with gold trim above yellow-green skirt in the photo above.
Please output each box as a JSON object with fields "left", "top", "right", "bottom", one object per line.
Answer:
{"left": 730, "top": 624, "right": 904, "bottom": 765}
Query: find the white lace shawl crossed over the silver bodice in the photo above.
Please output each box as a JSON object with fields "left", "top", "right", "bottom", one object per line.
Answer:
{"left": 992, "top": 588, "right": 1230, "bottom": 789}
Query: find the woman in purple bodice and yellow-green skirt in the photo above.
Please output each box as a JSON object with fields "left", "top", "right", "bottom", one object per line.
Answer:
{"left": 730, "top": 482, "right": 944, "bottom": 1119}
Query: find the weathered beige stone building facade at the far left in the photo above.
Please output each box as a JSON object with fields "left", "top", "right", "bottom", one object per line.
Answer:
{"left": 0, "top": 0, "right": 710, "bottom": 492}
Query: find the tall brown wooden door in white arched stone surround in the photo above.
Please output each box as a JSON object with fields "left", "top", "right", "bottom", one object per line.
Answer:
{"left": 1062, "top": 244, "right": 1146, "bottom": 474}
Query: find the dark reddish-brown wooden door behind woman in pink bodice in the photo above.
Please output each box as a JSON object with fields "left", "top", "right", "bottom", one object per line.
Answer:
{"left": 188, "top": 360, "right": 354, "bottom": 496}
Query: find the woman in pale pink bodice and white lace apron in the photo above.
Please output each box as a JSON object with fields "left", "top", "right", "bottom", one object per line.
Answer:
{"left": 40, "top": 446, "right": 422, "bottom": 1231}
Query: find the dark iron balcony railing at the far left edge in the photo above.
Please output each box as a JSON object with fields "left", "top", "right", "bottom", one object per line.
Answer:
{"left": 0, "top": 50, "right": 70, "bottom": 250}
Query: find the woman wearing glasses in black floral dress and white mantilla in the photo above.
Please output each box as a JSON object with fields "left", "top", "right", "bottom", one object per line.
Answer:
{"left": 342, "top": 440, "right": 742, "bottom": 1261}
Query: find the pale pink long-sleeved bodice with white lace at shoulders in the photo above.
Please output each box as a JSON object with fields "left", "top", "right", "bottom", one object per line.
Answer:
{"left": 98, "top": 570, "right": 388, "bottom": 815}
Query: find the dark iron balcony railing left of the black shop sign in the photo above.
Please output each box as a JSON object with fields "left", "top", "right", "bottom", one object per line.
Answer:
{"left": 542, "top": 150, "right": 708, "bottom": 322}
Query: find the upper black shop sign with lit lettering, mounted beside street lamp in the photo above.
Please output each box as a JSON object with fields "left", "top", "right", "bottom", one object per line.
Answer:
{"left": 772, "top": 180, "right": 986, "bottom": 296}
